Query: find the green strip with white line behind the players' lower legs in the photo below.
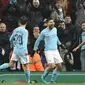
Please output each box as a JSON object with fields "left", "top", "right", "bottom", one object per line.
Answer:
{"left": 0, "top": 72, "right": 85, "bottom": 85}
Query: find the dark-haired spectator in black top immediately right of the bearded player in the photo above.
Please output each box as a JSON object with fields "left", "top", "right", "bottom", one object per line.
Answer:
{"left": 57, "top": 21, "right": 67, "bottom": 71}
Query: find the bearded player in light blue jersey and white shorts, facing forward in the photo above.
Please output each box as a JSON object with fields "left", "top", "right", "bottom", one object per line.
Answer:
{"left": 32, "top": 18, "right": 65, "bottom": 83}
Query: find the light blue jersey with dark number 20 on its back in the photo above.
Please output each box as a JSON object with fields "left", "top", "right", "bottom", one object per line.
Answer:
{"left": 10, "top": 27, "right": 28, "bottom": 55}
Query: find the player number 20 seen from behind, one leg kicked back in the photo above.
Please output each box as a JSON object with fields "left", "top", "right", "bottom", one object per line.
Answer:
{"left": 0, "top": 16, "right": 30, "bottom": 83}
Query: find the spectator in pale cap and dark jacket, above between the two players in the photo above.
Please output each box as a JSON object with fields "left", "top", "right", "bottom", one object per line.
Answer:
{"left": 25, "top": 0, "right": 51, "bottom": 35}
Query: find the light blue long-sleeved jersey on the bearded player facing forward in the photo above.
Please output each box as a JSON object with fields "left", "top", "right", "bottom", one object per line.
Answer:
{"left": 34, "top": 27, "right": 61, "bottom": 51}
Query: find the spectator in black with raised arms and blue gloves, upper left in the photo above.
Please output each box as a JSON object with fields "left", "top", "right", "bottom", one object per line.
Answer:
{"left": 2, "top": 0, "right": 21, "bottom": 32}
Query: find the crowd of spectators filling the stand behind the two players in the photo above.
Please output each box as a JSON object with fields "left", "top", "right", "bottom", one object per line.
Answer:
{"left": 0, "top": 0, "right": 85, "bottom": 71}
